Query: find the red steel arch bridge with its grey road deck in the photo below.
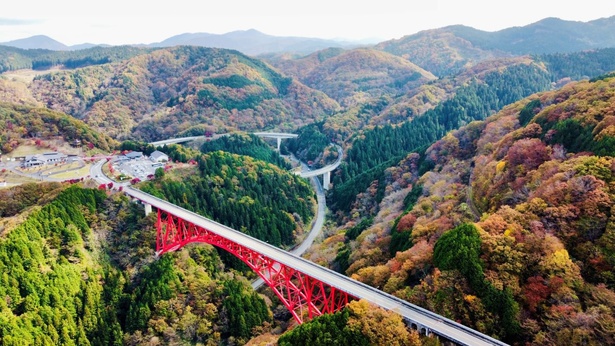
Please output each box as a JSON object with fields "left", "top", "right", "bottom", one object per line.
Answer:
{"left": 123, "top": 187, "right": 506, "bottom": 346}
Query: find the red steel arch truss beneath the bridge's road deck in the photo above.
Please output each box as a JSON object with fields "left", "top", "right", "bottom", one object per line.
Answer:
{"left": 156, "top": 209, "right": 354, "bottom": 323}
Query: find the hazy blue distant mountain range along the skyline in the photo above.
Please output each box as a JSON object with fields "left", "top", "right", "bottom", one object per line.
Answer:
{"left": 0, "top": 16, "right": 615, "bottom": 55}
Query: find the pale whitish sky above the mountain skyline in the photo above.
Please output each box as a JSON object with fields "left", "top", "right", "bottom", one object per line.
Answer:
{"left": 0, "top": 0, "right": 615, "bottom": 45}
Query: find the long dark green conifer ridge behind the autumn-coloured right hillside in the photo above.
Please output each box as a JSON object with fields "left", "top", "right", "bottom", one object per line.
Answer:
{"left": 282, "top": 49, "right": 615, "bottom": 216}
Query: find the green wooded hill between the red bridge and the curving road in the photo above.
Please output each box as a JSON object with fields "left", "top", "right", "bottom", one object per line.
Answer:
{"left": 140, "top": 151, "right": 315, "bottom": 246}
